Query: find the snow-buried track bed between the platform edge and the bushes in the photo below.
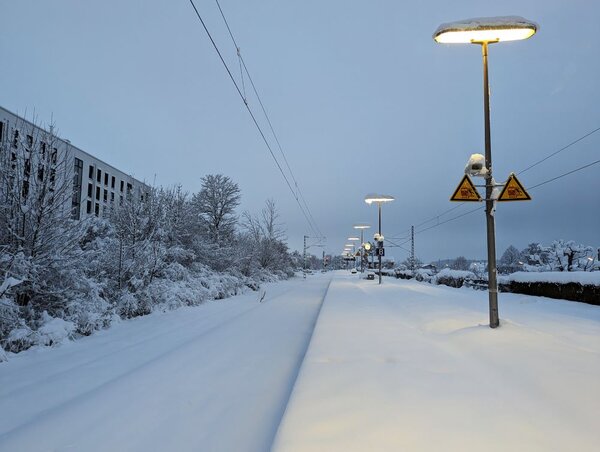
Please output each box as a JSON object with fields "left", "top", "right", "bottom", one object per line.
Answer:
{"left": 0, "top": 275, "right": 330, "bottom": 452}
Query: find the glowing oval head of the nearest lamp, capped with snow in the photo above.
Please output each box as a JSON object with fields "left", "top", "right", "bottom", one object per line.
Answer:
{"left": 433, "top": 16, "right": 539, "bottom": 44}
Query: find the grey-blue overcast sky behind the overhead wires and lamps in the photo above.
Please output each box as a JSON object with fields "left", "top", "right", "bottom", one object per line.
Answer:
{"left": 0, "top": 0, "right": 600, "bottom": 261}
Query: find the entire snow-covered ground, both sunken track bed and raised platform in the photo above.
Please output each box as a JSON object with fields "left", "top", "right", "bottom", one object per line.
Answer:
{"left": 0, "top": 272, "right": 600, "bottom": 452}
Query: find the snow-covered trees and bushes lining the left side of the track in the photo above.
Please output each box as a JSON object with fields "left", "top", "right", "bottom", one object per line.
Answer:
{"left": 0, "top": 122, "right": 300, "bottom": 354}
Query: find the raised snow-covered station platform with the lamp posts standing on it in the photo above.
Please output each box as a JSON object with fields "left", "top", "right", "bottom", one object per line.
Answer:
{"left": 273, "top": 275, "right": 600, "bottom": 452}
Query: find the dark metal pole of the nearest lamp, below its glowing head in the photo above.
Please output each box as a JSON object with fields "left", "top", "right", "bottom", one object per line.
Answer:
{"left": 481, "top": 42, "right": 500, "bottom": 328}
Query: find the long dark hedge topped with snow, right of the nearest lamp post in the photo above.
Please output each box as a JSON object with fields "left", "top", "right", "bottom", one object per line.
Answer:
{"left": 499, "top": 272, "right": 600, "bottom": 305}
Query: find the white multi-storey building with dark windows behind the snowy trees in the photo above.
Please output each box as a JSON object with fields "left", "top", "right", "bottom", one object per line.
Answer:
{"left": 0, "top": 107, "right": 149, "bottom": 219}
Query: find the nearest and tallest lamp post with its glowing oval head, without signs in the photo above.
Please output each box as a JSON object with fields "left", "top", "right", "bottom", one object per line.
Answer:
{"left": 433, "top": 16, "right": 538, "bottom": 328}
